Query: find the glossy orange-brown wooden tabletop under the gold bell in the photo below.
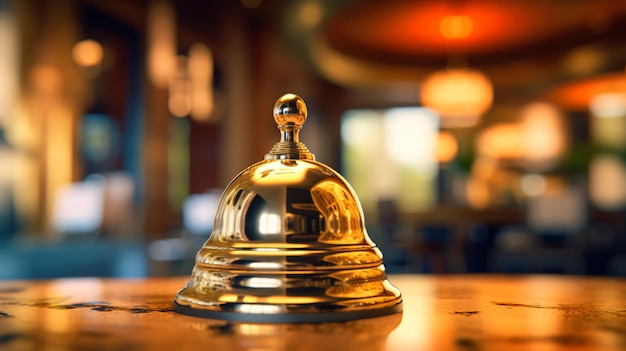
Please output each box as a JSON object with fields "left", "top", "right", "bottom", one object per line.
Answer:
{"left": 0, "top": 275, "right": 626, "bottom": 351}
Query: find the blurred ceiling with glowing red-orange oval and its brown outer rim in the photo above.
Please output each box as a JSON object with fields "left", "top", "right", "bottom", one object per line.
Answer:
{"left": 283, "top": 0, "right": 626, "bottom": 106}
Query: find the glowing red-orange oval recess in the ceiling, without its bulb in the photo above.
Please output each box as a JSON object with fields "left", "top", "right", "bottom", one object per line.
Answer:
{"left": 324, "top": 0, "right": 626, "bottom": 65}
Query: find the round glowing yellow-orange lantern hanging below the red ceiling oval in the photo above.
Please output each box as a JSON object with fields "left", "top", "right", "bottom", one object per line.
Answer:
{"left": 421, "top": 69, "right": 493, "bottom": 127}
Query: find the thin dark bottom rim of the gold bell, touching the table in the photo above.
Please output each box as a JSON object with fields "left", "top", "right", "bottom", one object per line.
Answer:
{"left": 174, "top": 301, "right": 402, "bottom": 323}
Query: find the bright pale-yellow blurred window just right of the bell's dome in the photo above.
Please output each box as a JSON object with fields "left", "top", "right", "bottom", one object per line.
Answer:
{"left": 341, "top": 107, "right": 439, "bottom": 217}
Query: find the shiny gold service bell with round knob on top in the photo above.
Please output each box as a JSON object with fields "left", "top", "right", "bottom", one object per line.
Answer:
{"left": 174, "top": 94, "right": 402, "bottom": 323}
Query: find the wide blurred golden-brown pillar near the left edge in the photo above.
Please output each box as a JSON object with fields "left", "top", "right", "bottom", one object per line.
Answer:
{"left": 15, "top": 1, "right": 85, "bottom": 233}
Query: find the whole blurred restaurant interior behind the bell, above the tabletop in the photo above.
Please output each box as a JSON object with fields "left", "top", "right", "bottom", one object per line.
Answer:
{"left": 0, "top": 0, "right": 626, "bottom": 279}
